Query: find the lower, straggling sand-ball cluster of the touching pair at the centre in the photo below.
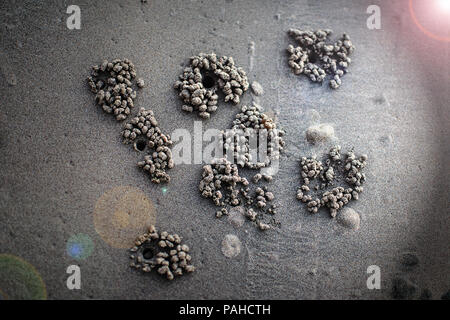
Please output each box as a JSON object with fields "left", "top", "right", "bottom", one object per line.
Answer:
{"left": 199, "top": 158, "right": 276, "bottom": 230}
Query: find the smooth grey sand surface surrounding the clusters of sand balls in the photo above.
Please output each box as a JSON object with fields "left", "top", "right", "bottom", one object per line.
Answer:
{"left": 0, "top": 0, "right": 450, "bottom": 299}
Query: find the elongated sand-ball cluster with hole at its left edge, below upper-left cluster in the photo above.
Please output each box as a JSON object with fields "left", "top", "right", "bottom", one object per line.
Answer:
{"left": 122, "top": 108, "right": 174, "bottom": 183}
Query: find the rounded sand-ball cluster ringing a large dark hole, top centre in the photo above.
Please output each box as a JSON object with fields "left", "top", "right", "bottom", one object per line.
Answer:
{"left": 174, "top": 53, "right": 249, "bottom": 119}
